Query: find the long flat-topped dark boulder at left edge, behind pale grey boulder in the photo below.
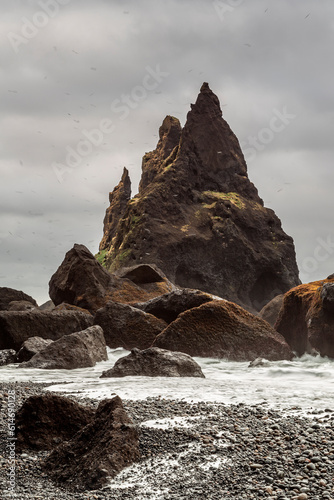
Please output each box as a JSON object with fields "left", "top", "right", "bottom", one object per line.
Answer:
{"left": 0, "top": 309, "right": 93, "bottom": 351}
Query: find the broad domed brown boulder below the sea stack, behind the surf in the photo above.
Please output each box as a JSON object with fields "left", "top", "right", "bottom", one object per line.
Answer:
{"left": 153, "top": 300, "right": 292, "bottom": 361}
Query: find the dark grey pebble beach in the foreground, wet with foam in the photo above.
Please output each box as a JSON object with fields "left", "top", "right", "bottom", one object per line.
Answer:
{"left": 0, "top": 382, "right": 334, "bottom": 500}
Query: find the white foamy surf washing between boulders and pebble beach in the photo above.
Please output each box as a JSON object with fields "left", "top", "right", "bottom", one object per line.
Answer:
{"left": 0, "top": 349, "right": 334, "bottom": 414}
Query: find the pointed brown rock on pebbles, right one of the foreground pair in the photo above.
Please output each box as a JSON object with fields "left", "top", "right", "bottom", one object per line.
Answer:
{"left": 44, "top": 396, "right": 140, "bottom": 490}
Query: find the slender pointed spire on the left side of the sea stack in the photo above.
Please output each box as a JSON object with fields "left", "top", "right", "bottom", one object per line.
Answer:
{"left": 99, "top": 168, "right": 131, "bottom": 251}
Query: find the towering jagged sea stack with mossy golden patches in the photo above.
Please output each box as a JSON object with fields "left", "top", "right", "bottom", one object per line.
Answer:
{"left": 102, "top": 84, "right": 300, "bottom": 311}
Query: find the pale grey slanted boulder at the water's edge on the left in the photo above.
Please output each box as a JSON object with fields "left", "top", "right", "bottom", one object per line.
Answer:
{"left": 20, "top": 325, "right": 108, "bottom": 370}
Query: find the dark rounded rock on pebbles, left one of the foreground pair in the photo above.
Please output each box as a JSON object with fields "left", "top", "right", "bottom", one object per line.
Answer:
{"left": 15, "top": 394, "right": 95, "bottom": 451}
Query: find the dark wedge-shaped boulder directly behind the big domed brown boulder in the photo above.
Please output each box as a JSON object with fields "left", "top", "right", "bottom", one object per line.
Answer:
{"left": 134, "top": 288, "right": 214, "bottom": 323}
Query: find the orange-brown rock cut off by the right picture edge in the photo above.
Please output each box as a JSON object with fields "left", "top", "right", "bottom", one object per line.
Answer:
{"left": 275, "top": 276, "right": 334, "bottom": 358}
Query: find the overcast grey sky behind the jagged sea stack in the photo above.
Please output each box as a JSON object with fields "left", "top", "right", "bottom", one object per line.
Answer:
{"left": 0, "top": 0, "right": 334, "bottom": 303}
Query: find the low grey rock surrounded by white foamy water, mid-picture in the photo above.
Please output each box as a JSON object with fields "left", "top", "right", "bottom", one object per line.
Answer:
{"left": 100, "top": 347, "right": 204, "bottom": 378}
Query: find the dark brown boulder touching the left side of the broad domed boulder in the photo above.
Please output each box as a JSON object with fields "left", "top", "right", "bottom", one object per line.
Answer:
{"left": 94, "top": 302, "right": 167, "bottom": 350}
